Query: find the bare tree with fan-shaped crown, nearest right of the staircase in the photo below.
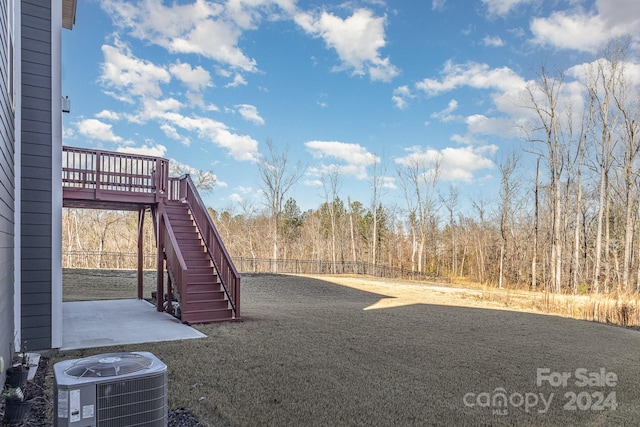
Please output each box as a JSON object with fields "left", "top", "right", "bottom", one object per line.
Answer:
{"left": 258, "top": 139, "right": 304, "bottom": 273}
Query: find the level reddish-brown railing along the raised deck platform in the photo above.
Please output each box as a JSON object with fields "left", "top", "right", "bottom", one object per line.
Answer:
{"left": 62, "top": 147, "right": 169, "bottom": 201}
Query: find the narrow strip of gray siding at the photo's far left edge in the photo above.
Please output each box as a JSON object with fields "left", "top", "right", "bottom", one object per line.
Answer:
{"left": 0, "top": 0, "right": 16, "bottom": 386}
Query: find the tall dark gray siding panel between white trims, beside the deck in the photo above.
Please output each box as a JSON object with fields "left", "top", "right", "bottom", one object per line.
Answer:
{"left": 21, "top": 0, "right": 53, "bottom": 350}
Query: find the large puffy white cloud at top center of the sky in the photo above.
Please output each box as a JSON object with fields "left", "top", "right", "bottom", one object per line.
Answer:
{"left": 295, "top": 9, "right": 399, "bottom": 81}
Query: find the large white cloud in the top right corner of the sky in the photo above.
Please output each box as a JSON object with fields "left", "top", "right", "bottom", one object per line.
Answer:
{"left": 531, "top": 0, "right": 640, "bottom": 52}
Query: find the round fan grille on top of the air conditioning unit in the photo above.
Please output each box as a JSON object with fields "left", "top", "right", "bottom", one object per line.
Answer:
{"left": 64, "top": 353, "right": 153, "bottom": 378}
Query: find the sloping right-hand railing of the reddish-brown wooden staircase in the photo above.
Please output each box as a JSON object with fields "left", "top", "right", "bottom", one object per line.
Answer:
{"left": 180, "top": 174, "right": 240, "bottom": 319}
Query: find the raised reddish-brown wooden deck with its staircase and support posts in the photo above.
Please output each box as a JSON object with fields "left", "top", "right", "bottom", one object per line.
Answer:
{"left": 62, "top": 147, "right": 240, "bottom": 323}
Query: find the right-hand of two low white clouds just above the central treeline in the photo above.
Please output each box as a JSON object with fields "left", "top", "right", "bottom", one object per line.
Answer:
{"left": 395, "top": 145, "right": 498, "bottom": 182}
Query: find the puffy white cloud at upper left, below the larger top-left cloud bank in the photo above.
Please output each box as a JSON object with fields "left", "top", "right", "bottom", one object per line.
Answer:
{"left": 100, "top": 42, "right": 171, "bottom": 102}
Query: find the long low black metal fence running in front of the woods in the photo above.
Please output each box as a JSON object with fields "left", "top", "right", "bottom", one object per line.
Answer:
{"left": 62, "top": 251, "right": 451, "bottom": 283}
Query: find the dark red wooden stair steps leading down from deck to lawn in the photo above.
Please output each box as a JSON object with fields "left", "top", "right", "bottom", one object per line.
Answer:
{"left": 165, "top": 201, "right": 234, "bottom": 323}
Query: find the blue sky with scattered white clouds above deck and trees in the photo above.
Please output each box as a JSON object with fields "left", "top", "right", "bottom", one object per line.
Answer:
{"left": 62, "top": 0, "right": 640, "bottom": 212}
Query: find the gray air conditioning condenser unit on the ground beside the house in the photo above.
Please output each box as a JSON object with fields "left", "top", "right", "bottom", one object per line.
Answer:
{"left": 53, "top": 352, "right": 168, "bottom": 427}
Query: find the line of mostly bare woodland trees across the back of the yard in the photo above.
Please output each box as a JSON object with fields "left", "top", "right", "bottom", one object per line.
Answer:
{"left": 63, "top": 44, "right": 640, "bottom": 293}
